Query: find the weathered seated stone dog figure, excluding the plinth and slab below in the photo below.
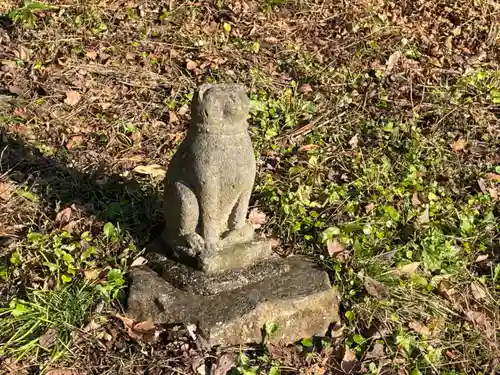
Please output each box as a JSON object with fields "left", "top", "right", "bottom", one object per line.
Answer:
{"left": 162, "top": 84, "right": 256, "bottom": 263}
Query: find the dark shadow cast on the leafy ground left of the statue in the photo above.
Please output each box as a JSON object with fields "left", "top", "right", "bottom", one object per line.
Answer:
{"left": 0, "top": 132, "right": 162, "bottom": 247}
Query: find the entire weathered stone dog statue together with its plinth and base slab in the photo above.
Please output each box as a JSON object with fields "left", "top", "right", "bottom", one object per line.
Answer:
{"left": 127, "top": 85, "right": 339, "bottom": 345}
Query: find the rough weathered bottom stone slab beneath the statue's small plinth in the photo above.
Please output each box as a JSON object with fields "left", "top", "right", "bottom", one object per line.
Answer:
{"left": 127, "top": 256, "right": 339, "bottom": 346}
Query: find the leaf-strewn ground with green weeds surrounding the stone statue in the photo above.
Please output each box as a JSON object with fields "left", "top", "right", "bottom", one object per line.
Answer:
{"left": 0, "top": 0, "right": 500, "bottom": 375}
